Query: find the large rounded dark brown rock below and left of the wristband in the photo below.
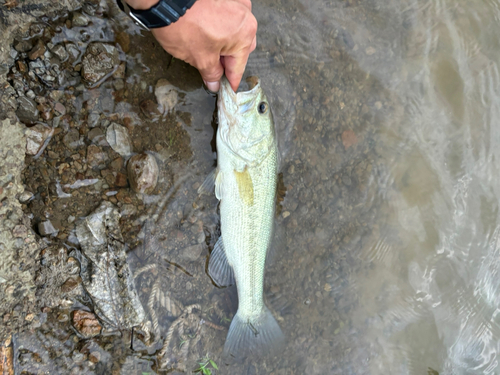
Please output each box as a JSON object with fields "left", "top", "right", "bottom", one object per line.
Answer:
{"left": 82, "top": 42, "right": 120, "bottom": 85}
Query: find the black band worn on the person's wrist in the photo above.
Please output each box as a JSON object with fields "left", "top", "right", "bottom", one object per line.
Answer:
{"left": 117, "top": 0, "right": 196, "bottom": 29}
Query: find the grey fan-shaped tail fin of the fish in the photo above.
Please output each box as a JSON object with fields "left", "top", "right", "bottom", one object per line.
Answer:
{"left": 224, "top": 306, "right": 285, "bottom": 358}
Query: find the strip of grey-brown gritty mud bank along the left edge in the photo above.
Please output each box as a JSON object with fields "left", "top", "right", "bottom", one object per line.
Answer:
{"left": 0, "top": 1, "right": 82, "bottom": 346}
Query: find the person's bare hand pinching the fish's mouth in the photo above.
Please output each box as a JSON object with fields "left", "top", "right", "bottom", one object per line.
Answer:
{"left": 127, "top": 0, "right": 257, "bottom": 92}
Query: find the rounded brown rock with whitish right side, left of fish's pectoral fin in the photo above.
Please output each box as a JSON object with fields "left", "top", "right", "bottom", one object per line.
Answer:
{"left": 127, "top": 153, "right": 159, "bottom": 194}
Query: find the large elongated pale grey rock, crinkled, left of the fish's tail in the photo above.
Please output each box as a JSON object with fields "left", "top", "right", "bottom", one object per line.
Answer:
{"left": 76, "top": 202, "right": 145, "bottom": 329}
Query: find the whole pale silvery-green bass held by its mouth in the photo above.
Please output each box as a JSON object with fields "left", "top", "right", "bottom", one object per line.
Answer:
{"left": 200, "top": 77, "right": 285, "bottom": 358}
